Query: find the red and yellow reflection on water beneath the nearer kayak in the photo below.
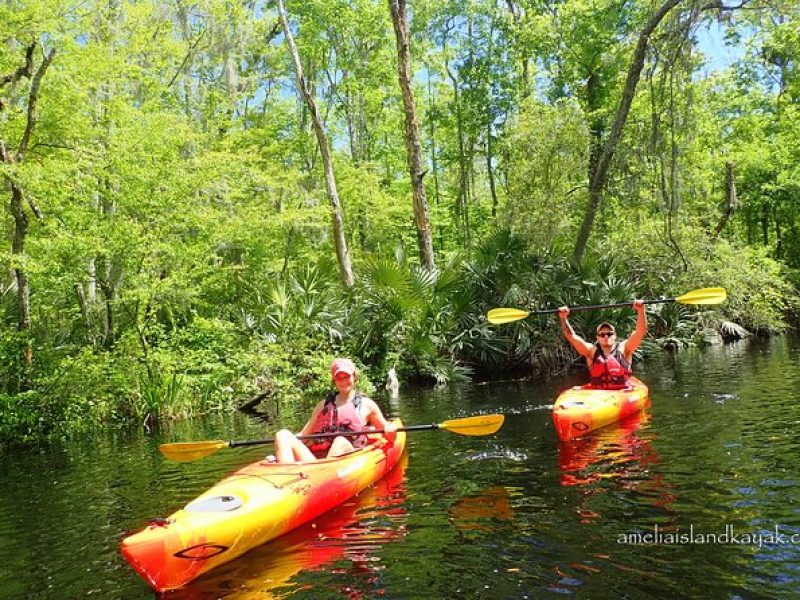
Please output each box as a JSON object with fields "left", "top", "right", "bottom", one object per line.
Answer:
{"left": 165, "top": 454, "right": 408, "bottom": 600}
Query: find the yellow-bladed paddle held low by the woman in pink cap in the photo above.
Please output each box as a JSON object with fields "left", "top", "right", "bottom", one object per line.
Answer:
{"left": 158, "top": 415, "right": 505, "bottom": 462}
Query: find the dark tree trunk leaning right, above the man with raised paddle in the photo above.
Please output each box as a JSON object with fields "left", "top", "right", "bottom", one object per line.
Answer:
{"left": 572, "top": 0, "right": 683, "bottom": 263}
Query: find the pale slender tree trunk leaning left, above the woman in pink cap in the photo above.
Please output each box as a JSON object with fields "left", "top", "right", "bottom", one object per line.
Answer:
{"left": 277, "top": 0, "right": 355, "bottom": 289}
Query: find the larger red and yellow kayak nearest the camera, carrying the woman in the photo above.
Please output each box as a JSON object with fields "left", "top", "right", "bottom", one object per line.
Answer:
{"left": 122, "top": 419, "right": 406, "bottom": 592}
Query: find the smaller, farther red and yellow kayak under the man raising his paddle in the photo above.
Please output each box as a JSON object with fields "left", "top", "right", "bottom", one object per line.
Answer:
{"left": 553, "top": 377, "right": 650, "bottom": 441}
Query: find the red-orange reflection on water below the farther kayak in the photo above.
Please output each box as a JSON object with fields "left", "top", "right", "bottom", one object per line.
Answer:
{"left": 558, "top": 410, "right": 676, "bottom": 523}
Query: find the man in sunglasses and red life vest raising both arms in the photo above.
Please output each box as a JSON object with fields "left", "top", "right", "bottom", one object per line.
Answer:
{"left": 558, "top": 300, "right": 647, "bottom": 390}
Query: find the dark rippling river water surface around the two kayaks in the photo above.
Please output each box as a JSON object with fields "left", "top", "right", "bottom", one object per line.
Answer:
{"left": 0, "top": 339, "right": 800, "bottom": 599}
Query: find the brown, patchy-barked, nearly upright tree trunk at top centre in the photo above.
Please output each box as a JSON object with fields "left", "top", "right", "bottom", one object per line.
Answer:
{"left": 388, "top": 0, "right": 436, "bottom": 271}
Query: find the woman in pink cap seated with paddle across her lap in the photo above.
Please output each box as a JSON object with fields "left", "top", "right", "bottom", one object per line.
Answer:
{"left": 275, "top": 358, "right": 397, "bottom": 463}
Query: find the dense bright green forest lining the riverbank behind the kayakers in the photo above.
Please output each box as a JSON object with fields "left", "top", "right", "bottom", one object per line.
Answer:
{"left": 0, "top": 0, "right": 800, "bottom": 443}
